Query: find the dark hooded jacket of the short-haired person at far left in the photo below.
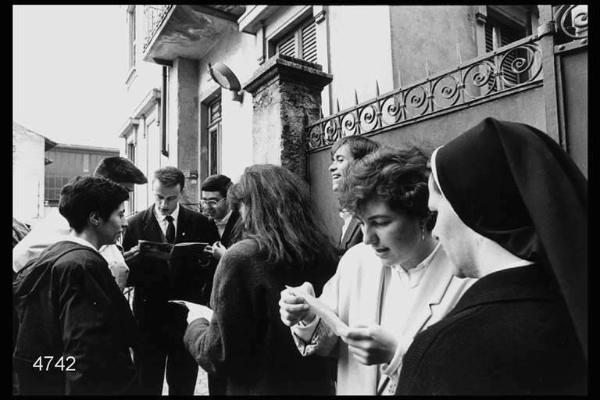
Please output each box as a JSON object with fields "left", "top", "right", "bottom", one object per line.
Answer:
{"left": 13, "top": 241, "right": 137, "bottom": 395}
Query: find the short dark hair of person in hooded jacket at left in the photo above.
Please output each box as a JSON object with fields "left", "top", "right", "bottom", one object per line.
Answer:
{"left": 58, "top": 176, "right": 129, "bottom": 233}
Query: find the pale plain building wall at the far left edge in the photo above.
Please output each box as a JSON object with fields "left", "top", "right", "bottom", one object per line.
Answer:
{"left": 12, "top": 121, "right": 56, "bottom": 224}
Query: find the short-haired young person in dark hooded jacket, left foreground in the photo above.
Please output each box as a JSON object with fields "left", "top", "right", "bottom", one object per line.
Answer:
{"left": 13, "top": 177, "right": 137, "bottom": 395}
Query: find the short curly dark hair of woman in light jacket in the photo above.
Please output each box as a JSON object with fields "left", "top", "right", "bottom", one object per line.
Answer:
{"left": 341, "top": 146, "right": 435, "bottom": 230}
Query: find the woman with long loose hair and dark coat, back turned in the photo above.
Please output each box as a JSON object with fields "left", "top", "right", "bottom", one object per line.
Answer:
{"left": 184, "top": 165, "right": 336, "bottom": 395}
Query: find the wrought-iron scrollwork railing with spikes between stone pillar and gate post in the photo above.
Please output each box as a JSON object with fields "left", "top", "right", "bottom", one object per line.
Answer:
{"left": 306, "top": 35, "right": 542, "bottom": 151}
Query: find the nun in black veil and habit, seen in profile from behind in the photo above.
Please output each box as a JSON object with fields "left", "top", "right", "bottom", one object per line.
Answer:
{"left": 396, "top": 118, "right": 588, "bottom": 395}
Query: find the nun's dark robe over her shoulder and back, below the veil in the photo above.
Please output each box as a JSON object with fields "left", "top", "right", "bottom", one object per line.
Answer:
{"left": 396, "top": 266, "right": 587, "bottom": 395}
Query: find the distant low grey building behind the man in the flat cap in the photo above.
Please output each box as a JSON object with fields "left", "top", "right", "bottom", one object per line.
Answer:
{"left": 44, "top": 143, "right": 119, "bottom": 212}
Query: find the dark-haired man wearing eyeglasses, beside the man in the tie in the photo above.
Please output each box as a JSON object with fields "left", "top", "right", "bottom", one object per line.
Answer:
{"left": 201, "top": 174, "right": 239, "bottom": 260}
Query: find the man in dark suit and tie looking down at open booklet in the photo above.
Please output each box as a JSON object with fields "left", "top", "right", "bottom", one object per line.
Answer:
{"left": 123, "top": 167, "right": 219, "bottom": 395}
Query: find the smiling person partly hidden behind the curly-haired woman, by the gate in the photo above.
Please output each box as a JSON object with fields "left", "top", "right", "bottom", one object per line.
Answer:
{"left": 329, "top": 136, "right": 379, "bottom": 256}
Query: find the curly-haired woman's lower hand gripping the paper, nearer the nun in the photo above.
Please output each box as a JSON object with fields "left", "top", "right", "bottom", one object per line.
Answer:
{"left": 342, "top": 325, "right": 398, "bottom": 365}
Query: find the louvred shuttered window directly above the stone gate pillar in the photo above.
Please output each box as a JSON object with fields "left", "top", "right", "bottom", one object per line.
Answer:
{"left": 274, "top": 17, "right": 317, "bottom": 63}
